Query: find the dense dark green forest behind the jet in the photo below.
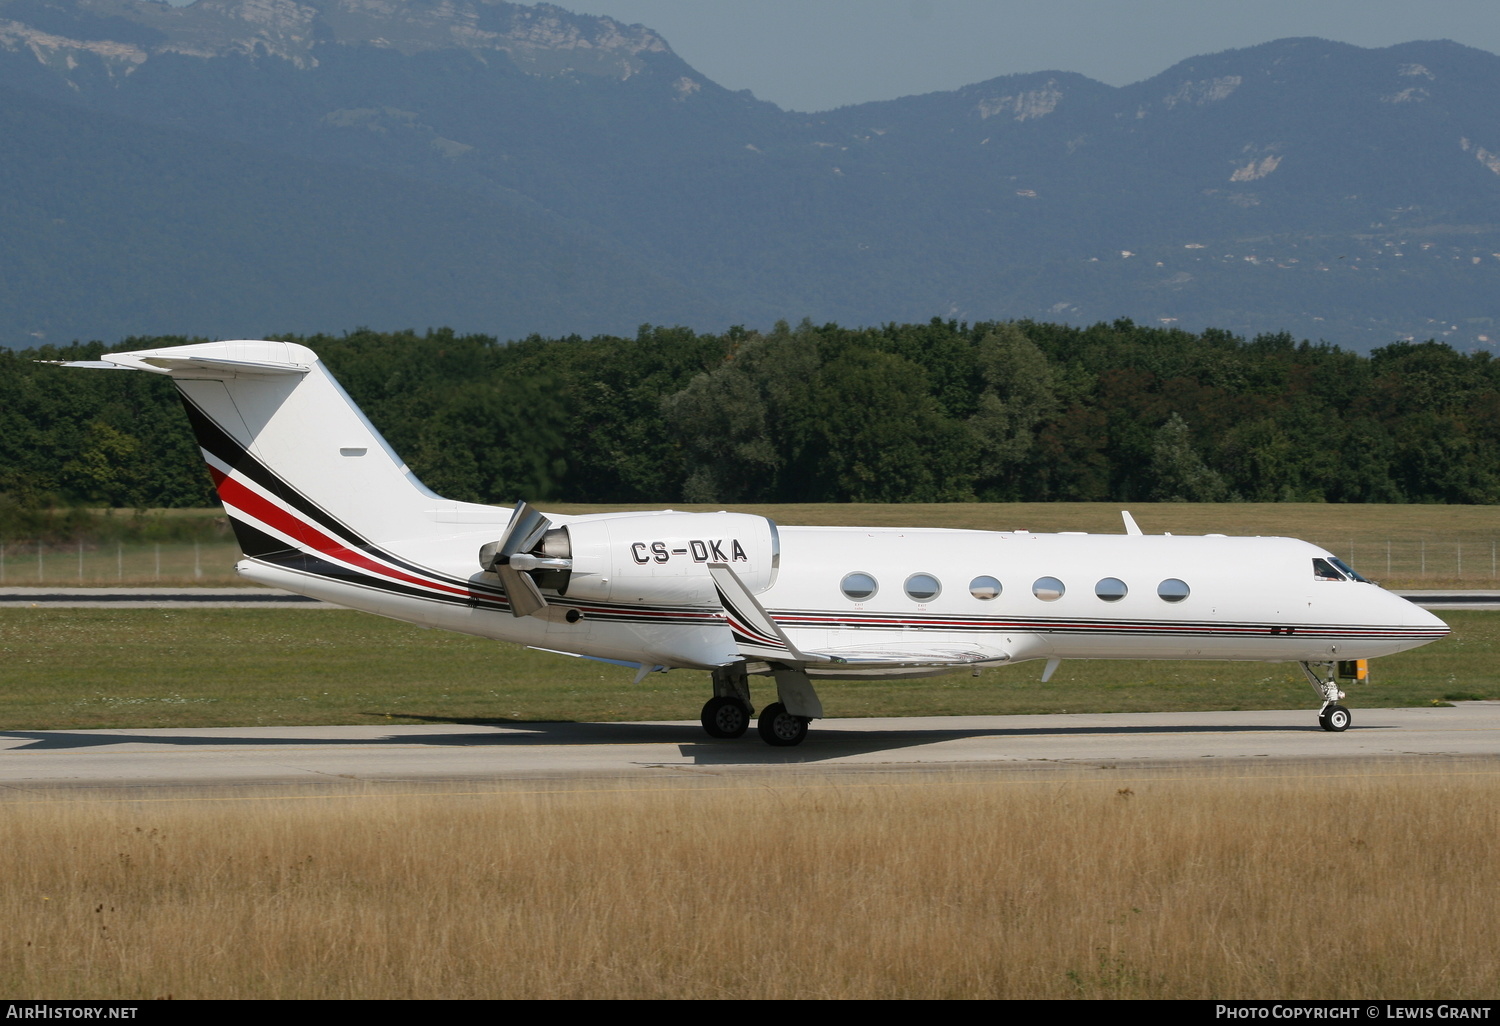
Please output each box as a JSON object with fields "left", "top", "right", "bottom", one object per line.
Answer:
{"left": 0, "top": 318, "right": 1500, "bottom": 522}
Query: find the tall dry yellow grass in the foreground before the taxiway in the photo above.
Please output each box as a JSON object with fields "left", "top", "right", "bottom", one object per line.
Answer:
{"left": 0, "top": 762, "right": 1500, "bottom": 999}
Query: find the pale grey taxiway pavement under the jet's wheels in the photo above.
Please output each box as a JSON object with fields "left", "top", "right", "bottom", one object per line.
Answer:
{"left": 0, "top": 702, "right": 1500, "bottom": 797}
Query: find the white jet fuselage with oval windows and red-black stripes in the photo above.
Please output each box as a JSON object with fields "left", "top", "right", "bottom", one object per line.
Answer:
{"left": 240, "top": 516, "right": 1448, "bottom": 677}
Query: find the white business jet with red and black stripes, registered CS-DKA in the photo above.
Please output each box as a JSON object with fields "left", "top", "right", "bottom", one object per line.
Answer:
{"left": 68, "top": 342, "right": 1448, "bottom": 746}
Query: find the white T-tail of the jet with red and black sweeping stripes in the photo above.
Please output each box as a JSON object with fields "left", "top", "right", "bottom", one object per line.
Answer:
{"left": 63, "top": 341, "right": 486, "bottom": 606}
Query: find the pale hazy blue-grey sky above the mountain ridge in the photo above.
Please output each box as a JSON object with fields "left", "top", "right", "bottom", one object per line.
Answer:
{"left": 558, "top": 0, "right": 1500, "bottom": 111}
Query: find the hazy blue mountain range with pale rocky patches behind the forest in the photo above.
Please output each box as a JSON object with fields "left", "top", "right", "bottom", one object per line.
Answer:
{"left": 0, "top": 0, "right": 1500, "bottom": 350}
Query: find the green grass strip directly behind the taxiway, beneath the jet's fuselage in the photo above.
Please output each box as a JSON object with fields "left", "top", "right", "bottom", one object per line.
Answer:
{"left": 0, "top": 609, "right": 1500, "bottom": 729}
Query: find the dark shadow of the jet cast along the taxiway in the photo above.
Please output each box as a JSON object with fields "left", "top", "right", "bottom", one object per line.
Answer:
{"left": 0, "top": 714, "right": 1382, "bottom": 765}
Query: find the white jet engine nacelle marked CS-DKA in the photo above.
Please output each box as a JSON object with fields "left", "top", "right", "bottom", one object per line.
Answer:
{"left": 561, "top": 512, "right": 780, "bottom": 605}
